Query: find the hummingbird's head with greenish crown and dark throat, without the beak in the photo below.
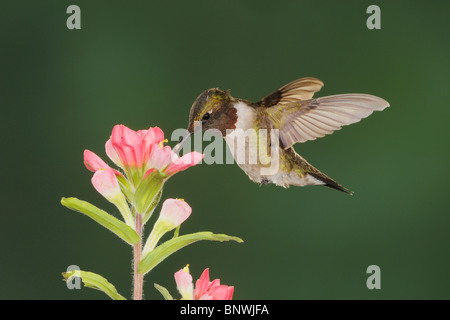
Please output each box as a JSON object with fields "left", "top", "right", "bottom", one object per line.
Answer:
{"left": 188, "top": 88, "right": 237, "bottom": 136}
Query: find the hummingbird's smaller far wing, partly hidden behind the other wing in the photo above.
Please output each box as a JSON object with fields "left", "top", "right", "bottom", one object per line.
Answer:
{"left": 256, "top": 77, "right": 323, "bottom": 108}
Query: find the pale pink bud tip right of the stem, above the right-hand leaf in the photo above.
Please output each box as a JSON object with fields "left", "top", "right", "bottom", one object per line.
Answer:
{"left": 159, "top": 199, "right": 192, "bottom": 231}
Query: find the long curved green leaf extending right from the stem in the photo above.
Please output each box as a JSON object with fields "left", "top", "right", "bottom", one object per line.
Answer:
{"left": 138, "top": 232, "right": 243, "bottom": 274}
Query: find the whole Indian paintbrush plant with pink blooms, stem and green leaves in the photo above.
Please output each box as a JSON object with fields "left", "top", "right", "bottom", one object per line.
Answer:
{"left": 61, "top": 125, "right": 242, "bottom": 300}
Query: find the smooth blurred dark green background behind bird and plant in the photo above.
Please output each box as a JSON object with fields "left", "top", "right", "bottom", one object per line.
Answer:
{"left": 0, "top": 0, "right": 450, "bottom": 299}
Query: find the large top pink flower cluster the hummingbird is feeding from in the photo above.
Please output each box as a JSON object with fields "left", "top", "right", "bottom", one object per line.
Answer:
{"left": 84, "top": 125, "right": 203, "bottom": 219}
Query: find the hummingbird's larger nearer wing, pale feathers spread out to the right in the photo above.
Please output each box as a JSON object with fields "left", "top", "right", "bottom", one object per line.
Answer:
{"left": 266, "top": 93, "right": 389, "bottom": 148}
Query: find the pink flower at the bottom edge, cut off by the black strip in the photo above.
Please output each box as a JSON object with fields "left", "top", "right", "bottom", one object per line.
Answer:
{"left": 175, "top": 267, "right": 234, "bottom": 300}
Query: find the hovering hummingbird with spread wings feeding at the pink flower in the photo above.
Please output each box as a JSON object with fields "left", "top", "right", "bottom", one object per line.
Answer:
{"left": 175, "top": 77, "right": 389, "bottom": 194}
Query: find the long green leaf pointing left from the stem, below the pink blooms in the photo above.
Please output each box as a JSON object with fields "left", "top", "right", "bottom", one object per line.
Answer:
{"left": 61, "top": 198, "right": 140, "bottom": 245}
